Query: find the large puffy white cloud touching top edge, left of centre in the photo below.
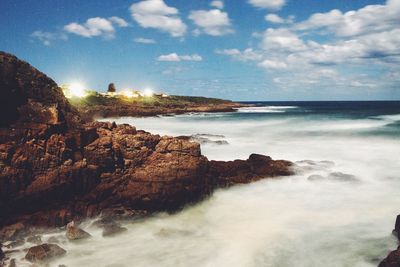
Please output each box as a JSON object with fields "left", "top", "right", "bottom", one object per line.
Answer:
{"left": 130, "top": 0, "right": 187, "bottom": 37}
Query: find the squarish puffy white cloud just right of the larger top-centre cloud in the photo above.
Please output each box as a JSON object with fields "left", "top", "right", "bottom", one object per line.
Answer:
{"left": 189, "top": 9, "right": 233, "bottom": 36}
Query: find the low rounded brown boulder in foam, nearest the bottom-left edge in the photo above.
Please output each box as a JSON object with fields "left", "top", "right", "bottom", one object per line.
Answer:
{"left": 25, "top": 244, "right": 67, "bottom": 262}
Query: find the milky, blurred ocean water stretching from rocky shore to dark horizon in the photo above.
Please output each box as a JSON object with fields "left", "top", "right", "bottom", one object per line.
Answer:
{"left": 37, "top": 101, "right": 400, "bottom": 267}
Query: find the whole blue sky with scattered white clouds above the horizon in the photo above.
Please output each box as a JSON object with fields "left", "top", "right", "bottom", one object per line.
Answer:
{"left": 0, "top": 0, "right": 400, "bottom": 101}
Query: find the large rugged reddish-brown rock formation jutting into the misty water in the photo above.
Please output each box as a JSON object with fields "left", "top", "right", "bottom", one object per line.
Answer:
{"left": 0, "top": 52, "right": 291, "bottom": 231}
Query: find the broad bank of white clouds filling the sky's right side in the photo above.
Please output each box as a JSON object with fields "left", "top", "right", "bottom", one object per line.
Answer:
{"left": 216, "top": 0, "right": 400, "bottom": 92}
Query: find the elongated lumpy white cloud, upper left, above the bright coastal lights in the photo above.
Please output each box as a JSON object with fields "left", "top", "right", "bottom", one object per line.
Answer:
{"left": 64, "top": 17, "right": 128, "bottom": 39}
